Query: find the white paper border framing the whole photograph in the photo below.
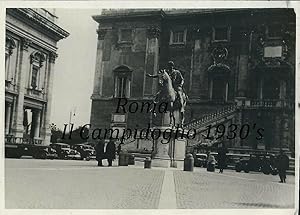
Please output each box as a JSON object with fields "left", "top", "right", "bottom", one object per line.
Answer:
{"left": 0, "top": 0, "right": 300, "bottom": 215}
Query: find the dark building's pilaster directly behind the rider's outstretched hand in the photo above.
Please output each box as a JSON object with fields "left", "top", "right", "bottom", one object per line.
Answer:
{"left": 143, "top": 27, "right": 160, "bottom": 96}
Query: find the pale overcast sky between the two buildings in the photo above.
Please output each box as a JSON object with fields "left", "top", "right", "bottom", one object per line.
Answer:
{"left": 51, "top": 9, "right": 100, "bottom": 128}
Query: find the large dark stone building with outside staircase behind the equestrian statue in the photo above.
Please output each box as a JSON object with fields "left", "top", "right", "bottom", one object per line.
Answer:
{"left": 91, "top": 9, "right": 296, "bottom": 153}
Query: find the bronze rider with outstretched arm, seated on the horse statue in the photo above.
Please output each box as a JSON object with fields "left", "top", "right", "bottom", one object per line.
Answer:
{"left": 147, "top": 61, "right": 184, "bottom": 110}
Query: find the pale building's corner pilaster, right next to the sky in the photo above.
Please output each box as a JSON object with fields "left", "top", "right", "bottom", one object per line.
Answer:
{"left": 43, "top": 52, "right": 57, "bottom": 145}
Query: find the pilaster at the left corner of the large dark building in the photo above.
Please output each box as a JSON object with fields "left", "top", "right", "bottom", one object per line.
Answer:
{"left": 93, "top": 29, "right": 107, "bottom": 95}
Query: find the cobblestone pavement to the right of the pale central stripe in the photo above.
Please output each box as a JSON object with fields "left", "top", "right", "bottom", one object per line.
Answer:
{"left": 174, "top": 168, "right": 294, "bottom": 209}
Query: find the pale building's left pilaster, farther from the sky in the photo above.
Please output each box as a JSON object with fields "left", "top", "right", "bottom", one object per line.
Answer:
{"left": 12, "top": 38, "right": 31, "bottom": 137}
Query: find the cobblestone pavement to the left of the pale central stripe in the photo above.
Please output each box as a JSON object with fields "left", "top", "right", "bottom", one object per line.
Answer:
{"left": 5, "top": 159, "right": 164, "bottom": 209}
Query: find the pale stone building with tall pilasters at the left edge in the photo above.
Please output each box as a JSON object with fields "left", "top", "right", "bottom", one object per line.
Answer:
{"left": 5, "top": 8, "right": 69, "bottom": 144}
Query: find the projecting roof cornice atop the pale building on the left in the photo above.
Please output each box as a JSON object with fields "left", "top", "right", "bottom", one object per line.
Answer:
{"left": 7, "top": 8, "right": 69, "bottom": 41}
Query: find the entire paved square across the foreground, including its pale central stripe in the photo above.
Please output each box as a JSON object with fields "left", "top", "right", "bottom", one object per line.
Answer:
{"left": 5, "top": 159, "right": 295, "bottom": 209}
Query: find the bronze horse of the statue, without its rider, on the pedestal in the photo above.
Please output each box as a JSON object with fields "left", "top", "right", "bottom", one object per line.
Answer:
{"left": 157, "top": 70, "right": 188, "bottom": 126}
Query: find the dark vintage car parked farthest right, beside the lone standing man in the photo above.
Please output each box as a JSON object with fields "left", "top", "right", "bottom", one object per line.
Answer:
{"left": 235, "top": 154, "right": 278, "bottom": 175}
